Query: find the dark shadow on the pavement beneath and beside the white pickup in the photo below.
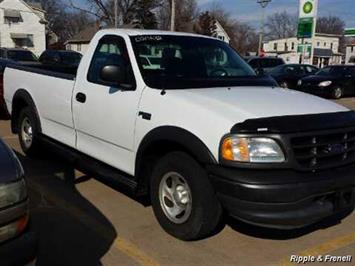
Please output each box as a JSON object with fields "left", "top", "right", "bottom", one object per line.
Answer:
{"left": 16, "top": 151, "right": 351, "bottom": 247}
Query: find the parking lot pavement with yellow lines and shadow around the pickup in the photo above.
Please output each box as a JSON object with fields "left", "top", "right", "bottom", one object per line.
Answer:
{"left": 0, "top": 98, "right": 355, "bottom": 266}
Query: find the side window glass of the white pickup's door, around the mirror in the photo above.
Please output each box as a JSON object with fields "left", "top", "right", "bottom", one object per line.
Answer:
{"left": 87, "top": 35, "right": 135, "bottom": 85}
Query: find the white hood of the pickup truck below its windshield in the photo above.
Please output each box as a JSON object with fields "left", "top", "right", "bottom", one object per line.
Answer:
{"left": 168, "top": 87, "right": 349, "bottom": 123}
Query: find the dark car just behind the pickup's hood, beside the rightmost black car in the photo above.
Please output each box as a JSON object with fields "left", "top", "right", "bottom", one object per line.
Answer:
{"left": 269, "top": 64, "right": 319, "bottom": 89}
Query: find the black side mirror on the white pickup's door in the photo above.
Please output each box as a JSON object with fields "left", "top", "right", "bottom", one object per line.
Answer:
{"left": 100, "top": 65, "right": 134, "bottom": 90}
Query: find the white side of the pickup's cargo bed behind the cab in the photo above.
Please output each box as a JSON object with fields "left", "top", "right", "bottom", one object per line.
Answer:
{"left": 4, "top": 65, "right": 76, "bottom": 146}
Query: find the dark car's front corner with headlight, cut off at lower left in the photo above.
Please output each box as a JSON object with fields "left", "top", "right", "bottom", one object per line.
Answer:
{"left": 0, "top": 139, "right": 37, "bottom": 265}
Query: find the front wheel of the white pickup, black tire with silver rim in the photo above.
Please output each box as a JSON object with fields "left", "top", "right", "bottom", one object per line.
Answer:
{"left": 150, "top": 152, "right": 222, "bottom": 241}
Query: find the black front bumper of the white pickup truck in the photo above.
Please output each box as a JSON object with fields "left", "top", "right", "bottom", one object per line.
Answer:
{"left": 209, "top": 165, "right": 355, "bottom": 229}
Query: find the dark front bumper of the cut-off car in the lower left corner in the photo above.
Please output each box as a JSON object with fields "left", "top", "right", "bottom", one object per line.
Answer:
{"left": 0, "top": 229, "right": 38, "bottom": 266}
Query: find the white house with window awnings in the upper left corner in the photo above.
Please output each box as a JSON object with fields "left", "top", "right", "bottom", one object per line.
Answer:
{"left": 0, "top": 0, "right": 46, "bottom": 55}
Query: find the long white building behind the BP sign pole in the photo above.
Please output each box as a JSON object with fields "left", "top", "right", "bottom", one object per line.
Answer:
{"left": 263, "top": 33, "right": 343, "bottom": 67}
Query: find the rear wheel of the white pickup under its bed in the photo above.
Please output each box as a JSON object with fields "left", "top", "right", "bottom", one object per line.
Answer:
{"left": 18, "top": 107, "right": 41, "bottom": 157}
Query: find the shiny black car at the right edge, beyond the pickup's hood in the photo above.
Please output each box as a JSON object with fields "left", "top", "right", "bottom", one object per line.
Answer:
{"left": 298, "top": 65, "right": 355, "bottom": 99}
